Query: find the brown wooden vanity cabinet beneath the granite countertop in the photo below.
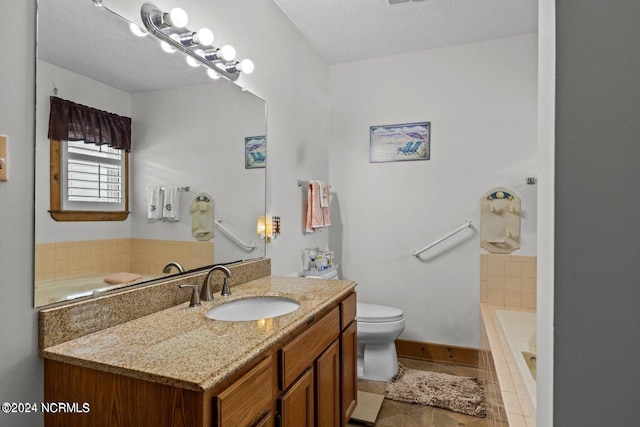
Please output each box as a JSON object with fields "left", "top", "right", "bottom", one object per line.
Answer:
{"left": 44, "top": 293, "right": 357, "bottom": 427}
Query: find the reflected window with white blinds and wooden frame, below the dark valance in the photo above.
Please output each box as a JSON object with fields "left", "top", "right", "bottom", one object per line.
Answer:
{"left": 50, "top": 140, "right": 129, "bottom": 221}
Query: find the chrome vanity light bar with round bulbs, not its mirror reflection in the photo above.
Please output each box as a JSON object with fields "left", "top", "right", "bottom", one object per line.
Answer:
{"left": 140, "top": 3, "right": 254, "bottom": 81}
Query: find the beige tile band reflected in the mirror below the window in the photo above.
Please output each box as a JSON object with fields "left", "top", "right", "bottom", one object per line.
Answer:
{"left": 35, "top": 239, "right": 214, "bottom": 286}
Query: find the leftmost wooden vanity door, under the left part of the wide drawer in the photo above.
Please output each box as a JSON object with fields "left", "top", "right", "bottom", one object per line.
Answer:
{"left": 278, "top": 368, "right": 314, "bottom": 427}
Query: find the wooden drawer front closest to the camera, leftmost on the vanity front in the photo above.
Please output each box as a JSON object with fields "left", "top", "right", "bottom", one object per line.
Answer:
{"left": 216, "top": 355, "right": 273, "bottom": 427}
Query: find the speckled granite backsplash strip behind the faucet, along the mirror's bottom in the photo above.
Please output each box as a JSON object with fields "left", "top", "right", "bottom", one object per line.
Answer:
{"left": 38, "top": 258, "right": 271, "bottom": 352}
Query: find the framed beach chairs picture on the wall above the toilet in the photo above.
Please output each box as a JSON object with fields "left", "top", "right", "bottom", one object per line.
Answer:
{"left": 369, "top": 122, "right": 431, "bottom": 163}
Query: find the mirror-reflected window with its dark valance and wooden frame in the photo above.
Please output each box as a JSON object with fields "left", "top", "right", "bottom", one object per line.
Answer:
{"left": 49, "top": 96, "right": 131, "bottom": 221}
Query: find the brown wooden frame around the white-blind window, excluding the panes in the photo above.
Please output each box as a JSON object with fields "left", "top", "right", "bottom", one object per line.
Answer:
{"left": 49, "top": 139, "right": 129, "bottom": 221}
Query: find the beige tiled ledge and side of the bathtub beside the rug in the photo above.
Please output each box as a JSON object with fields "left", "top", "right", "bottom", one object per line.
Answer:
{"left": 480, "top": 303, "right": 536, "bottom": 427}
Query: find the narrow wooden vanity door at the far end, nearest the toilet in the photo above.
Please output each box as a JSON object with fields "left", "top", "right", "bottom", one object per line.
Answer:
{"left": 340, "top": 321, "right": 358, "bottom": 427}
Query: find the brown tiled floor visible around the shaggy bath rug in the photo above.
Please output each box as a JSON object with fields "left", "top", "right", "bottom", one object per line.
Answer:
{"left": 349, "top": 358, "right": 492, "bottom": 427}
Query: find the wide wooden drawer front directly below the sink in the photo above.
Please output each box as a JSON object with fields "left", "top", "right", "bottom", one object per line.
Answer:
{"left": 280, "top": 307, "right": 340, "bottom": 390}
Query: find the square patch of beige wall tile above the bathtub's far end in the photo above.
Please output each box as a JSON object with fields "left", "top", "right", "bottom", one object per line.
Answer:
{"left": 480, "top": 254, "right": 537, "bottom": 310}
